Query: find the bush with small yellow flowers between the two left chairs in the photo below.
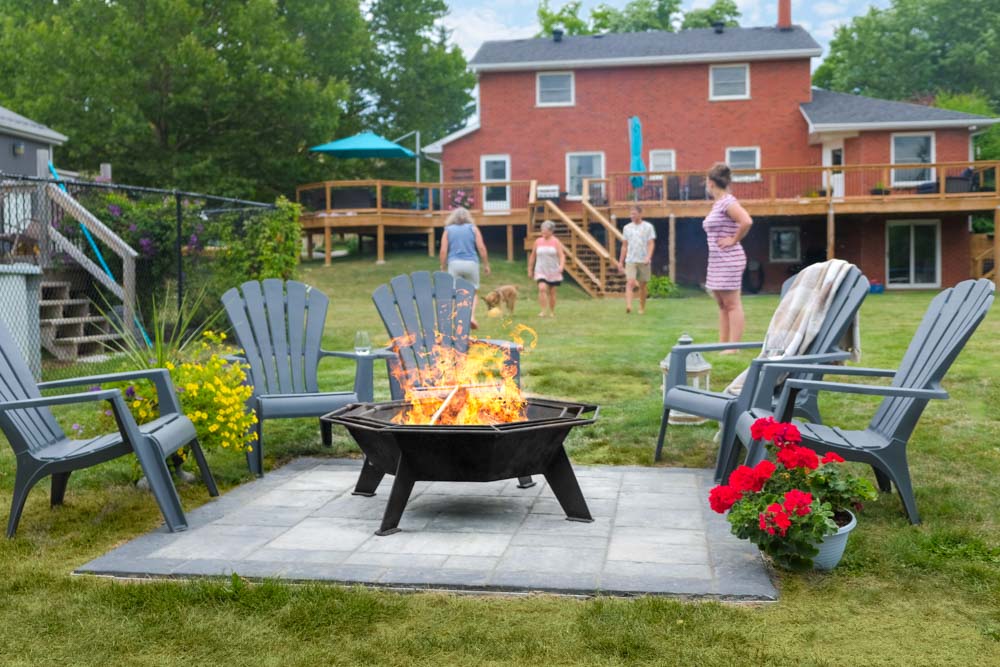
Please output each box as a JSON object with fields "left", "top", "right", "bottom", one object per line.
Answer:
{"left": 101, "top": 331, "right": 257, "bottom": 452}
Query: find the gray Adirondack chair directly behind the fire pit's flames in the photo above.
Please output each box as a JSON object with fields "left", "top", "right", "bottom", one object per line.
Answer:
{"left": 359, "top": 271, "right": 535, "bottom": 495}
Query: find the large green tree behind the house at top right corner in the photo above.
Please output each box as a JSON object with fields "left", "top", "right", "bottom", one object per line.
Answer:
{"left": 813, "top": 0, "right": 1000, "bottom": 107}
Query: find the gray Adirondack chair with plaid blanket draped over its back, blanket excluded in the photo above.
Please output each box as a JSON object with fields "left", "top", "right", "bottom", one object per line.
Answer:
{"left": 655, "top": 266, "right": 869, "bottom": 480}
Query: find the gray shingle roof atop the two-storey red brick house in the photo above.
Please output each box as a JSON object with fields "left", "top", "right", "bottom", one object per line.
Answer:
{"left": 469, "top": 26, "right": 821, "bottom": 70}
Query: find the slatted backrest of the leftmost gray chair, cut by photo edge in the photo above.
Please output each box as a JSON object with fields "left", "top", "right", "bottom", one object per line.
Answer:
{"left": 0, "top": 322, "right": 66, "bottom": 454}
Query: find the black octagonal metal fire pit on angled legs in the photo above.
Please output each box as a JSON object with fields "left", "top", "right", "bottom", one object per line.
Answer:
{"left": 322, "top": 398, "right": 598, "bottom": 535}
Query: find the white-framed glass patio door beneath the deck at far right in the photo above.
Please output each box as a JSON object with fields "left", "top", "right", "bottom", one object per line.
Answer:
{"left": 885, "top": 220, "right": 941, "bottom": 287}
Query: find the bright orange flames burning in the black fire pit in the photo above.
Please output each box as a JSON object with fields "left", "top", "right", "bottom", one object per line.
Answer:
{"left": 392, "top": 325, "right": 537, "bottom": 426}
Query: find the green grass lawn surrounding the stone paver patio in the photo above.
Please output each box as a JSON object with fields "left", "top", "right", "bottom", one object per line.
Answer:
{"left": 0, "top": 254, "right": 1000, "bottom": 666}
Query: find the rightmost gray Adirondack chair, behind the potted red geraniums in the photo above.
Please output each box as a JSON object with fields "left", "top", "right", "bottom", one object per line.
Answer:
{"left": 736, "top": 279, "right": 994, "bottom": 524}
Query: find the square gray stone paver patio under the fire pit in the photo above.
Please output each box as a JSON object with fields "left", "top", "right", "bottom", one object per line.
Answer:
{"left": 77, "top": 458, "right": 777, "bottom": 600}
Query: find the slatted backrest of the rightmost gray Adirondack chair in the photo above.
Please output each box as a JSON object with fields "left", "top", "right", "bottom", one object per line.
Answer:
{"left": 870, "top": 280, "right": 994, "bottom": 440}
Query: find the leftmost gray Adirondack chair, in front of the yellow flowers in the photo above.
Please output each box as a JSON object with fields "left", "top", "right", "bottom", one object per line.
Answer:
{"left": 0, "top": 322, "right": 219, "bottom": 537}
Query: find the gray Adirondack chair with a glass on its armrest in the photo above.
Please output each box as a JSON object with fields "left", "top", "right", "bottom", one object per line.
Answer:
{"left": 222, "top": 279, "right": 386, "bottom": 477}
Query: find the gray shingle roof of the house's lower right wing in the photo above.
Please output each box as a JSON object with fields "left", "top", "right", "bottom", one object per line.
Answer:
{"left": 801, "top": 88, "right": 998, "bottom": 129}
